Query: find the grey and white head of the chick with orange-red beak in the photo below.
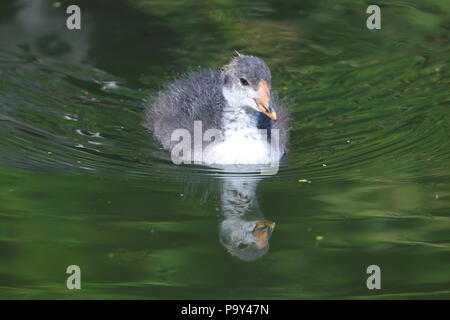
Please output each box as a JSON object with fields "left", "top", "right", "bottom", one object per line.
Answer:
{"left": 222, "top": 55, "right": 277, "bottom": 120}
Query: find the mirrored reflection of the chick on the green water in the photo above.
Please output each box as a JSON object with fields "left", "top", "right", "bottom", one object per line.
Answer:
{"left": 220, "top": 177, "right": 275, "bottom": 261}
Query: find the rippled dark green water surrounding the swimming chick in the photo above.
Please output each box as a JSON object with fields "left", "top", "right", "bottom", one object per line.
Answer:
{"left": 0, "top": 0, "right": 450, "bottom": 299}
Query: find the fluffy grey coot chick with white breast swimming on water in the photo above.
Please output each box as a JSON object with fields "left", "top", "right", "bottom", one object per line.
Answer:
{"left": 146, "top": 55, "right": 287, "bottom": 164}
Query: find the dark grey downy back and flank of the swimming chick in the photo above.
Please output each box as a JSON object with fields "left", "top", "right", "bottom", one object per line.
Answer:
{"left": 145, "top": 70, "right": 225, "bottom": 149}
